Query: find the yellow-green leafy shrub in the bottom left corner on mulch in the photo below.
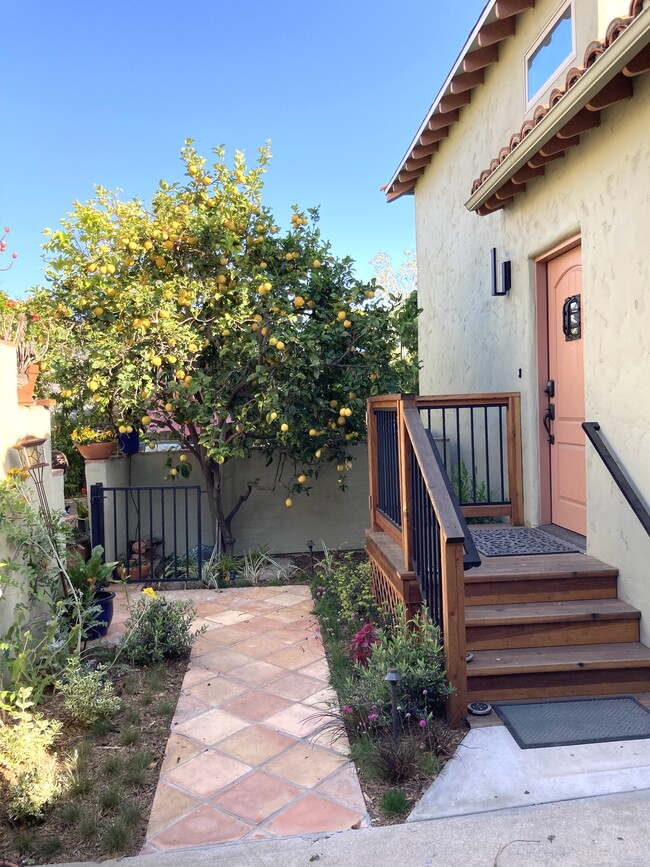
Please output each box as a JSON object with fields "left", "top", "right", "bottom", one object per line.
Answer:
{"left": 0, "top": 688, "right": 64, "bottom": 821}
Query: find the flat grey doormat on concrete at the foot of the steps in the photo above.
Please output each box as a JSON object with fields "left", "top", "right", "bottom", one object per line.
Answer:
{"left": 494, "top": 698, "right": 650, "bottom": 750}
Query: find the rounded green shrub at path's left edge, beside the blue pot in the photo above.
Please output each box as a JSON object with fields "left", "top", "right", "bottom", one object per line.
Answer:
{"left": 121, "top": 591, "right": 205, "bottom": 665}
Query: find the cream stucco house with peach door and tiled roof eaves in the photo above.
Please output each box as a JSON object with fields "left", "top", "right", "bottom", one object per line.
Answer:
{"left": 386, "top": 0, "right": 650, "bottom": 644}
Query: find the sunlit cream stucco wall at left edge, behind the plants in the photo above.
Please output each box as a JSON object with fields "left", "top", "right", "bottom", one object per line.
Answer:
{"left": 0, "top": 340, "right": 64, "bottom": 635}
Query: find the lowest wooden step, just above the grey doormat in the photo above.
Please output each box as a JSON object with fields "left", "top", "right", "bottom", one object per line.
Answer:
{"left": 467, "top": 641, "right": 650, "bottom": 701}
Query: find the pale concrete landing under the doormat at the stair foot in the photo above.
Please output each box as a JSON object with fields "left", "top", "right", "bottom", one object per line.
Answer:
{"left": 408, "top": 726, "right": 650, "bottom": 822}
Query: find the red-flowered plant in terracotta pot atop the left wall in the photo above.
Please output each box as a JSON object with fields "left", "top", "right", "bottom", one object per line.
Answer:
{"left": 0, "top": 292, "right": 50, "bottom": 404}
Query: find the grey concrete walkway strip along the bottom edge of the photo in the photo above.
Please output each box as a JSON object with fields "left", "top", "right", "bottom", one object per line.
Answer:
{"left": 57, "top": 792, "right": 650, "bottom": 867}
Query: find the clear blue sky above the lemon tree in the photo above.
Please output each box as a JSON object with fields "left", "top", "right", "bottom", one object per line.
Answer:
{"left": 0, "top": 0, "right": 484, "bottom": 296}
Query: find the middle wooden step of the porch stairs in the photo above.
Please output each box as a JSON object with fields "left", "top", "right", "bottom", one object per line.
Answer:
{"left": 465, "top": 599, "right": 641, "bottom": 651}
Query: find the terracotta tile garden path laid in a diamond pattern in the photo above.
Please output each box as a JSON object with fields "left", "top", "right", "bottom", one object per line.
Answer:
{"left": 109, "top": 585, "right": 369, "bottom": 853}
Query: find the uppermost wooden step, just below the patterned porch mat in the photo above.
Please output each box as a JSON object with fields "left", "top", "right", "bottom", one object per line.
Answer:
{"left": 465, "top": 553, "right": 618, "bottom": 605}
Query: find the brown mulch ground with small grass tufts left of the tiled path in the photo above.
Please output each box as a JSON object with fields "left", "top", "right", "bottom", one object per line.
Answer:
{"left": 0, "top": 660, "right": 187, "bottom": 865}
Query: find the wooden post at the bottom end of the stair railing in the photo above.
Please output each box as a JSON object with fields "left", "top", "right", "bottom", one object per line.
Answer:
{"left": 440, "top": 537, "right": 467, "bottom": 728}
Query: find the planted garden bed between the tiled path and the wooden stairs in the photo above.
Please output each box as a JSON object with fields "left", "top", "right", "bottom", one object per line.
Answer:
{"left": 312, "top": 552, "right": 465, "bottom": 825}
